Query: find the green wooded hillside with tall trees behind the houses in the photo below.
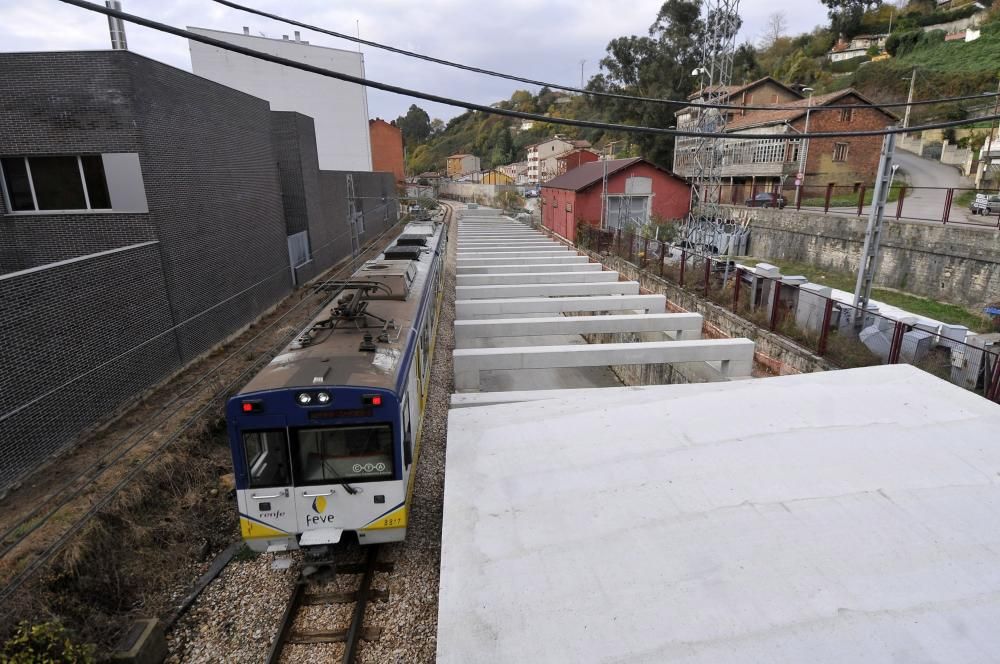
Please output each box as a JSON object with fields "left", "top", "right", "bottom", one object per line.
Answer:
{"left": 396, "top": 0, "right": 1000, "bottom": 174}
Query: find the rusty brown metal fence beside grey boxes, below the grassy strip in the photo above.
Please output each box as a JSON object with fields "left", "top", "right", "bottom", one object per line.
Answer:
{"left": 577, "top": 226, "right": 1000, "bottom": 402}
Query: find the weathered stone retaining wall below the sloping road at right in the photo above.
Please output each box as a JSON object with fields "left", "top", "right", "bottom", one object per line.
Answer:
{"left": 750, "top": 208, "right": 1000, "bottom": 308}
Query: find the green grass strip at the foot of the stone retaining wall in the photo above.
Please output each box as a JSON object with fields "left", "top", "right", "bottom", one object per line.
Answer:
{"left": 740, "top": 258, "right": 992, "bottom": 332}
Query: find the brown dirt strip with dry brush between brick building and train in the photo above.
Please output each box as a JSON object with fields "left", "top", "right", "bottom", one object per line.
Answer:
{"left": 0, "top": 226, "right": 406, "bottom": 647}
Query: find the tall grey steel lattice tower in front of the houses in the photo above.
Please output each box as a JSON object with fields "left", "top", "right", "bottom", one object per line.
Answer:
{"left": 677, "top": 0, "right": 740, "bottom": 251}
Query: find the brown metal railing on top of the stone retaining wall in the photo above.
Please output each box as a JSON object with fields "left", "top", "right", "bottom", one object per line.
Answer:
{"left": 721, "top": 183, "right": 1000, "bottom": 228}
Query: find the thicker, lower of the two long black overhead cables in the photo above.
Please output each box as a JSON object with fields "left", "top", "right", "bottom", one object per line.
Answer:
{"left": 59, "top": 0, "right": 1000, "bottom": 140}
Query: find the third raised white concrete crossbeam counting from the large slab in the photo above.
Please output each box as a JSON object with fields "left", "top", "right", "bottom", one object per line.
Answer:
{"left": 455, "top": 294, "right": 667, "bottom": 320}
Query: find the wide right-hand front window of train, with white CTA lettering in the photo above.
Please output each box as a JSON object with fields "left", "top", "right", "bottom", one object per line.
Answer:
{"left": 293, "top": 424, "right": 395, "bottom": 484}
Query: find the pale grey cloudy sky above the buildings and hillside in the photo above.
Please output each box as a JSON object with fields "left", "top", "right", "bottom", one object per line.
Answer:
{"left": 0, "top": 0, "right": 826, "bottom": 119}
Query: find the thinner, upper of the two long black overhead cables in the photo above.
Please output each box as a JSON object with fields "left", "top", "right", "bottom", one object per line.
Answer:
{"left": 207, "top": 0, "right": 998, "bottom": 111}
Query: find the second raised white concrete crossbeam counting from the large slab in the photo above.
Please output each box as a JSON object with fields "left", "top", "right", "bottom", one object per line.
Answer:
{"left": 455, "top": 314, "right": 702, "bottom": 346}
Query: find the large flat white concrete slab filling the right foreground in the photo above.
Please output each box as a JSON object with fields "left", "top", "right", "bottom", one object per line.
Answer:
{"left": 437, "top": 365, "right": 1000, "bottom": 664}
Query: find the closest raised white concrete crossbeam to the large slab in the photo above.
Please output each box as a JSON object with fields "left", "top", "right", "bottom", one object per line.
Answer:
{"left": 452, "top": 339, "right": 754, "bottom": 391}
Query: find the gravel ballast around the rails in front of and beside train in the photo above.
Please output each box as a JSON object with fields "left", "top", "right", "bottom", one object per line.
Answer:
{"left": 167, "top": 205, "right": 457, "bottom": 664}
